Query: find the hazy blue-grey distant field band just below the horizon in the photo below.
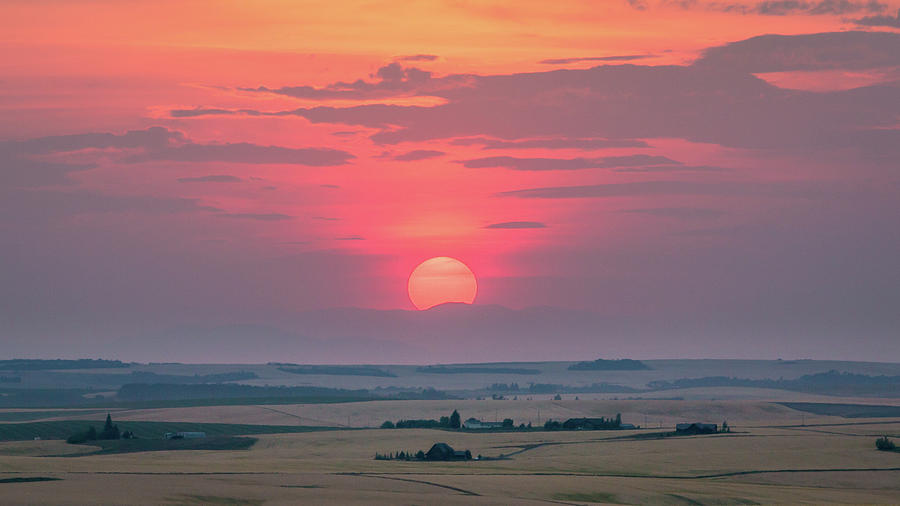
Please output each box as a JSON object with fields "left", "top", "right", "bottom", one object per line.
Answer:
{"left": 3, "top": 357, "right": 900, "bottom": 399}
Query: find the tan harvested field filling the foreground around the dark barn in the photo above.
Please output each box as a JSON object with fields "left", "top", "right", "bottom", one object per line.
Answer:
{"left": 0, "top": 401, "right": 900, "bottom": 505}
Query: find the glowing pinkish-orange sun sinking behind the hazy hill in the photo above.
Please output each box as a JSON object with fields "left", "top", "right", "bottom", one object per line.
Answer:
{"left": 408, "top": 257, "right": 478, "bottom": 309}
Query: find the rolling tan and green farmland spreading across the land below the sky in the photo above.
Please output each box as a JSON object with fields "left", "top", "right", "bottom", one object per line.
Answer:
{"left": 0, "top": 361, "right": 900, "bottom": 505}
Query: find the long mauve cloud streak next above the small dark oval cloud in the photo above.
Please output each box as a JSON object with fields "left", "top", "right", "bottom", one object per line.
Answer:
{"left": 496, "top": 181, "right": 823, "bottom": 199}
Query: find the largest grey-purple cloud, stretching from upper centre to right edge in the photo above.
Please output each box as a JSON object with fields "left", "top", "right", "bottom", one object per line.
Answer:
{"left": 169, "top": 32, "right": 900, "bottom": 154}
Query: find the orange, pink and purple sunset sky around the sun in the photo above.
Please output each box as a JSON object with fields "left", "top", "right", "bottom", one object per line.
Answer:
{"left": 0, "top": 0, "right": 900, "bottom": 363}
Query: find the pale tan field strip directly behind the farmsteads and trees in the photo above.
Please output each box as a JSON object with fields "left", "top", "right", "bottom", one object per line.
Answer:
{"left": 0, "top": 396, "right": 884, "bottom": 428}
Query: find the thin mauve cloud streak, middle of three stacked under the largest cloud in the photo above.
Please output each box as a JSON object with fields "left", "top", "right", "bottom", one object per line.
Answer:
{"left": 459, "top": 154, "right": 679, "bottom": 171}
